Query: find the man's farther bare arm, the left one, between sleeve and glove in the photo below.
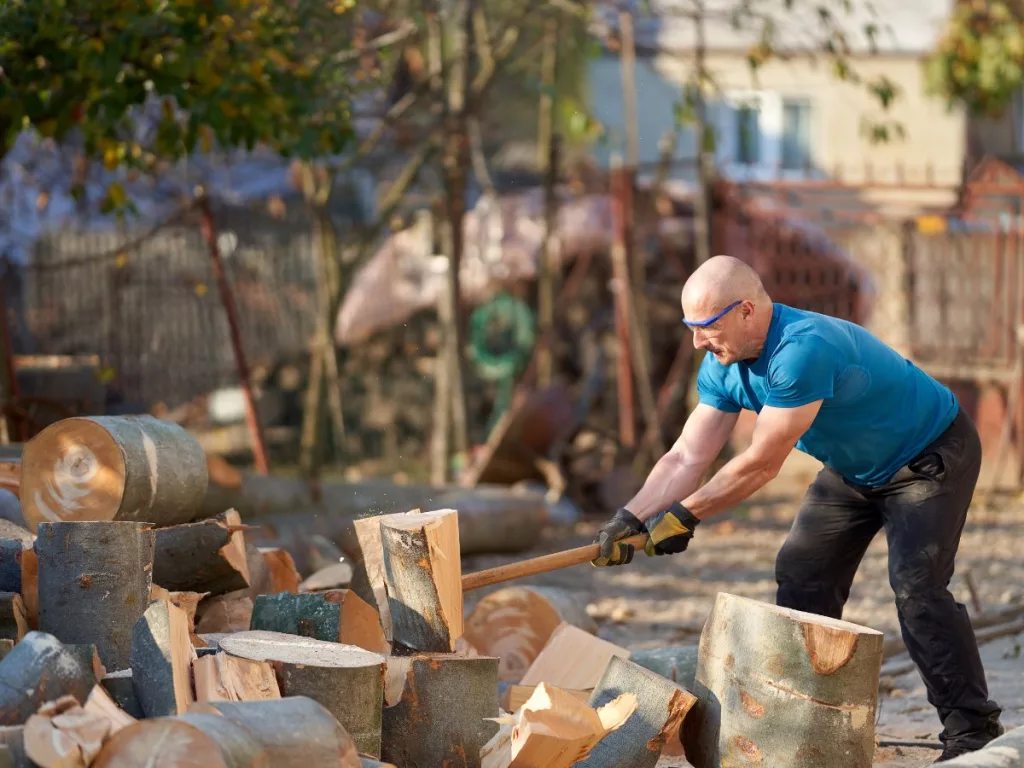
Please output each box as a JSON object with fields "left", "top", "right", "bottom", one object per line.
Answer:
{"left": 626, "top": 402, "right": 739, "bottom": 520}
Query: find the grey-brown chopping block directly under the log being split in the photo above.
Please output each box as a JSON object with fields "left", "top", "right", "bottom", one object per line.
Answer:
{"left": 381, "top": 653, "right": 499, "bottom": 768}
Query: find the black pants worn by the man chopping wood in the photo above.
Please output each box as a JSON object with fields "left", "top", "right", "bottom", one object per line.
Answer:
{"left": 775, "top": 411, "right": 1002, "bottom": 749}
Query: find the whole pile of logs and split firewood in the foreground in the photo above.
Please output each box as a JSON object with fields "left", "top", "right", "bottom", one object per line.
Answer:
{"left": 0, "top": 417, "right": 933, "bottom": 768}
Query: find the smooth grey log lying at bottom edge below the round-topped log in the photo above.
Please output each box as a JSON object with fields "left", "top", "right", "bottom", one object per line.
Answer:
{"left": 190, "top": 696, "right": 360, "bottom": 768}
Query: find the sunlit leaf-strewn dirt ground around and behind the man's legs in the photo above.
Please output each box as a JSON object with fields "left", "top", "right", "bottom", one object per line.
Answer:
{"left": 463, "top": 454, "right": 1024, "bottom": 768}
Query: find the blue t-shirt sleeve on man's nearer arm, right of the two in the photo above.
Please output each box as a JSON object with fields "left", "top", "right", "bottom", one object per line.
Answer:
{"left": 765, "top": 336, "right": 841, "bottom": 408}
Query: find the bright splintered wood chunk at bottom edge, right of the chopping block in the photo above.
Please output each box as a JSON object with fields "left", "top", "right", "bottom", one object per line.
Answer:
{"left": 480, "top": 683, "right": 637, "bottom": 768}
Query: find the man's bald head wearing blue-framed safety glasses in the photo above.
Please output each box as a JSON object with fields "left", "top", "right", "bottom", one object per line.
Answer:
{"left": 681, "top": 256, "right": 773, "bottom": 365}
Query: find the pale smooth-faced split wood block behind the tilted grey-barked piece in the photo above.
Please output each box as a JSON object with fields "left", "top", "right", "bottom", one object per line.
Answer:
{"left": 520, "top": 623, "right": 630, "bottom": 690}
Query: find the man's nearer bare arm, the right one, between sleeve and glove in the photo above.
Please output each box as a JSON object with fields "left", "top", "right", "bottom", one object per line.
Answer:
{"left": 677, "top": 400, "right": 821, "bottom": 520}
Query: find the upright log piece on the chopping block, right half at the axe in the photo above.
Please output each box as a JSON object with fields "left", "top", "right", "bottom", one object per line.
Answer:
{"left": 380, "top": 509, "right": 463, "bottom": 652}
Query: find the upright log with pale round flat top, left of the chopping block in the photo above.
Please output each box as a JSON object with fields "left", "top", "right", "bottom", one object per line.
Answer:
{"left": 220, "top": 631, "right": 386, "bottom": 757}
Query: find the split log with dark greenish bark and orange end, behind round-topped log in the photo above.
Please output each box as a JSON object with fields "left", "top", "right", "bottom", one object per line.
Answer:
{"left": 250, "top": 590, "right": 390, "bottom": 655}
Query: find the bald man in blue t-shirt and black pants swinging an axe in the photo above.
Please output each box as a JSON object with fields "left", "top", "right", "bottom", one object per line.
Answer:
{"left": 594, "top": 256, "right": 1002, "bottom": 762}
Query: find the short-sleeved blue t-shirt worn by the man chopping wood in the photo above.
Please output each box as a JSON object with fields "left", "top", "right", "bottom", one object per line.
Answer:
{"left": 697, "top": 304, "right": 958, "bottom": 486}
